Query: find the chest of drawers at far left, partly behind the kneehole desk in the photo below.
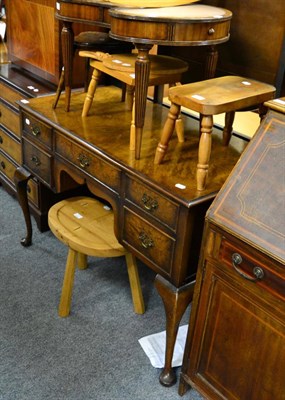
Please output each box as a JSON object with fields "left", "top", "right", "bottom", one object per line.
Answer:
{"left": 0, "top": 64, "right": 57, "bottom": 230}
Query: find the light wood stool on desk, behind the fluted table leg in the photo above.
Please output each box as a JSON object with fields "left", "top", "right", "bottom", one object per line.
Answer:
{"left": 79, "top": 51, "right": 188, "bottom": 150}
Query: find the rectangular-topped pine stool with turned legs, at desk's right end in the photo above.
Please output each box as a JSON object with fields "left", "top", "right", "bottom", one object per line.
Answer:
{"left": 154, "top": 76, "right": 275, "bottom": 190}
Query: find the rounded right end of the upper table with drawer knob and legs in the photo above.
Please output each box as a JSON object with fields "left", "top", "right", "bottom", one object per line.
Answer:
{"left": 109, "top": 2, "right": 232, "bottom": 159}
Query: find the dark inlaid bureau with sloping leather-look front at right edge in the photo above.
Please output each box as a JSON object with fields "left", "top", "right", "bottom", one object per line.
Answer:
{"left": 179, "top": 98, "right": 285, "bottom": 400}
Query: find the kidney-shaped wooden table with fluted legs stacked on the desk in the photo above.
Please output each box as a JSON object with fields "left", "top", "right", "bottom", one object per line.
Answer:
{"left": 56, "top": 0, "right": 232, "bottom": 159}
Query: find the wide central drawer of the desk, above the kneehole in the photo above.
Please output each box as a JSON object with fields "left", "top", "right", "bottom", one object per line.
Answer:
{"left": 55, "top": 132, "right": 121, "bottom": 192}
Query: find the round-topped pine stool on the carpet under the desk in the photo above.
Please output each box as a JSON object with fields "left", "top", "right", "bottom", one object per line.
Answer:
{"left": 48, "top": 197, "right": 145, "bottom": 317}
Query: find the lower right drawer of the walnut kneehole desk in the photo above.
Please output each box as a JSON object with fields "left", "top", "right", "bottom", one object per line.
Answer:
{"left": 122, "top": 207, "right": 175, "bottom": 277}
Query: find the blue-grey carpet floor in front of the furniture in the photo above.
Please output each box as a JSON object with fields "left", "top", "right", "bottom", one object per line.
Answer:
{"left": 0, "top": 187, "right": 202, "bottom": 400}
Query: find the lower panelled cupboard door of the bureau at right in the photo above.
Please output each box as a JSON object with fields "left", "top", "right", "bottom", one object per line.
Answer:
{"left": 187, "top": 263, "right": 285, "bottom": 400}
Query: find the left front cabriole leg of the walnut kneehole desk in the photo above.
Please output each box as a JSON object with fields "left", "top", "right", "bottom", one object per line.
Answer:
{"left": 14, "top": 167, "right": 32, "bottom": 247}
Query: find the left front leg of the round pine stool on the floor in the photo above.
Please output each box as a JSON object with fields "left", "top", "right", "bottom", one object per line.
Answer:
{"left": 58, "top": 248, "right": 77, "bottom": 317}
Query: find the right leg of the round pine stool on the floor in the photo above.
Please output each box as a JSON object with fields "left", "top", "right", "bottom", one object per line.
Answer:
{"left": 126, "top": 253, "right": 145, "bottom": 314}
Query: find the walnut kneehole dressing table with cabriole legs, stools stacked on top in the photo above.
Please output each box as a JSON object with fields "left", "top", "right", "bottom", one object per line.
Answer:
{"left": 15, "top": 86, "right": 244, "bottom": 386}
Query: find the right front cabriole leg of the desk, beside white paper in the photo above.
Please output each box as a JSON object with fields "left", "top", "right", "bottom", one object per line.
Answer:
{"left": 154, "top": 275, "right": 195, "bottom": 387}
